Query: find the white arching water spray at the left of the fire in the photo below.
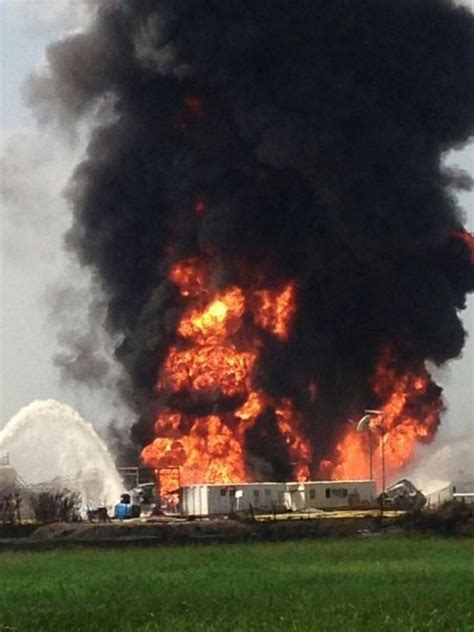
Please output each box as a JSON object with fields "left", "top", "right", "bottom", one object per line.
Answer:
{"left": 0, "top": 399, "right": 123, "bottom": 506}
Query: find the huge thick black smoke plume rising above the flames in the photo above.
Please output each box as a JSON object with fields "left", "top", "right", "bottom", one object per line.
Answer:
{"left": 30, "top": 0, "right": 474, "bottom": 469}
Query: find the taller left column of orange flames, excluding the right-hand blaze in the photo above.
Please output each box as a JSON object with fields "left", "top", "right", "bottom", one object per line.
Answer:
{"left": 142, "top": 259, "right": 312, "bottom": 493}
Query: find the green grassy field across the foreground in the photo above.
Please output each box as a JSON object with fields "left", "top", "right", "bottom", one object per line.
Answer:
{"left": 0, "top": 538, "right": 474, "bottom": 632}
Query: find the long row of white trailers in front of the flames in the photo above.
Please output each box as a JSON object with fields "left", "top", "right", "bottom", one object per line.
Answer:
{"left": 180, "top": 481, "right": 376, "bottom": 516}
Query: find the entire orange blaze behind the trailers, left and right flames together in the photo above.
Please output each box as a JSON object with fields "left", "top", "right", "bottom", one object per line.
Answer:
{"left": 142, "top": 252, "right": 442, "bottom": 494}
